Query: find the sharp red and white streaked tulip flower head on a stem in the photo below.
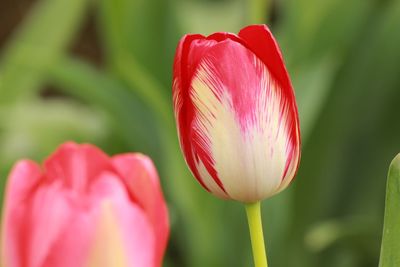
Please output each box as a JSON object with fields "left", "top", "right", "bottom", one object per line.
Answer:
{"left": 173, "top": 25, "right": 300, "bottom": 202}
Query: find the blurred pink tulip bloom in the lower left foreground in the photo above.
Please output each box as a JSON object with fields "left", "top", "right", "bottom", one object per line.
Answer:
{"left": 1, "top": 142, "right": 169, "bottom": 267}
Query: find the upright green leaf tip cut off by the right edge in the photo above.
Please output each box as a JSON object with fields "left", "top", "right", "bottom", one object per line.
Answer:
{"left": 379, "top": 154, "right": 400, "bottom": 267}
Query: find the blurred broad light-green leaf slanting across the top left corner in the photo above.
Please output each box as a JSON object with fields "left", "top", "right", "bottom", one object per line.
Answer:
{"left": 0, "top": 0, "right": 90, "bottom": 104}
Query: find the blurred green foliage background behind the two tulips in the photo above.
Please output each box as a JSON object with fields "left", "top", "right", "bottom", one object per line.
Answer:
{"left": 0, "top": 0, "right": 400, "bottom": 267}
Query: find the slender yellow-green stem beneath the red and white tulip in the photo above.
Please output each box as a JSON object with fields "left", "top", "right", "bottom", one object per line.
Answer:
{"left": 246, "top": 202, "right": 268, "bottom": 267}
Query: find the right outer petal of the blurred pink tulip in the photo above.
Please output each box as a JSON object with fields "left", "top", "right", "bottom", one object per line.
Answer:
{"left": 112, "top": 153, "right": 169, "bottom": 266}
